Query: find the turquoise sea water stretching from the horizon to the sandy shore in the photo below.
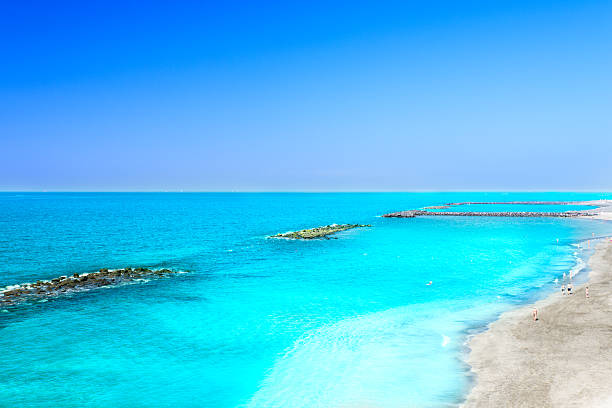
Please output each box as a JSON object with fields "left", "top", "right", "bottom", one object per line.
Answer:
{"left": 0, "top": 193, "right": 612, "bottom": 407}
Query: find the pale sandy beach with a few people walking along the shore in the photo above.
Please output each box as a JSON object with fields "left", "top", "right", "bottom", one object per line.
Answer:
{"left": 463, "top": 239, "right": 612, "bottom": 407}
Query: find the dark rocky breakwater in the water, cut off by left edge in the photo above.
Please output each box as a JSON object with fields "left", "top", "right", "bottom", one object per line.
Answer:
{"left": 0, "top": 268, "right": 177, "bottom": 303}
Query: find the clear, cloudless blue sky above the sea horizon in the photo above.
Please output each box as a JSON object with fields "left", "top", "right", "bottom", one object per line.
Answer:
{"left": 0, "top": 0, "right": 612, "bottom": 191}
